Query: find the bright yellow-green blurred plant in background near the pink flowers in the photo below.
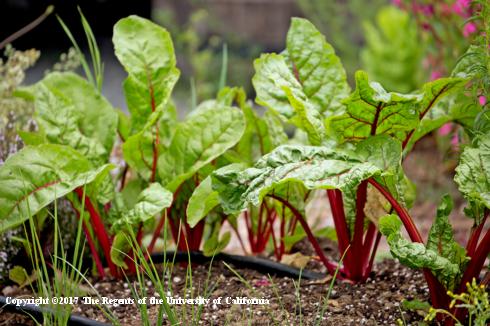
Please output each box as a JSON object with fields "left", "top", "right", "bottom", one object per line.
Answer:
{"left": 361, "top": 6, "right": 424, "bottom": 92}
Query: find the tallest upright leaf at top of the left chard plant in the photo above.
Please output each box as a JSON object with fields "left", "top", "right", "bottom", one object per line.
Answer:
{"left": 112, "top": 16, "right": 180, "bottom": 133}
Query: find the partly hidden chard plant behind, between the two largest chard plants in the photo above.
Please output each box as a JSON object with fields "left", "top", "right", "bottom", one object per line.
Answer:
{"left": 187, "top": 88, "right": 307, "bottom": 260}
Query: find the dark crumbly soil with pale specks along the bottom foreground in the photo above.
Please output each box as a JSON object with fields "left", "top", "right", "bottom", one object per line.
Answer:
{"left": 0, "top": 260, "right": 428, "bottom": 326}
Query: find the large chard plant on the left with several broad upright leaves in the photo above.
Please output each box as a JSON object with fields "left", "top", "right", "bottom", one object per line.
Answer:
{"left": 0, "top": 16, "right": 245, "bottom": 277}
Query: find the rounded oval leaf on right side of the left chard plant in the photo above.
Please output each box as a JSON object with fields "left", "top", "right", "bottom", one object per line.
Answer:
{"left": 158, "top": 104, "right": 245, "bottom": 191}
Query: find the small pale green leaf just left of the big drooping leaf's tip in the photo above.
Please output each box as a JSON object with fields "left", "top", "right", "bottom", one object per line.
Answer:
{"left": 187, "top": 176, "right": 219, "bottom": 228}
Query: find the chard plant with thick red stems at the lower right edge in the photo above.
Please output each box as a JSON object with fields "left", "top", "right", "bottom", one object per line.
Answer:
{"left": 376, "top": 125, "right": 490, "bottom": 323}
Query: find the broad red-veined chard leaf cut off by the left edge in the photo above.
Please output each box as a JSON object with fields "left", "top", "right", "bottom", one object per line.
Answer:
{"left": 0, "top": 144, "right": 112, "bottom": 232}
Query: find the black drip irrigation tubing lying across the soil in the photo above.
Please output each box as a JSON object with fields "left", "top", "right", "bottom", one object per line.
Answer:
{"left": 0, "top": 251, "right": 325, "bottom": 326}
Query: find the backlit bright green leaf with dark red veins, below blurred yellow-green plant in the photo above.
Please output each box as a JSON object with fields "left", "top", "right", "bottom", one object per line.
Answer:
{"left": 329, "top": 71, "right": 465, "bottom": 146}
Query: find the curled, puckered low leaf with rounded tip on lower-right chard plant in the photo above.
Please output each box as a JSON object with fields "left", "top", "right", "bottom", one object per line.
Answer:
{"left": 379, "top": 215, "right": 460, "bottom": 289}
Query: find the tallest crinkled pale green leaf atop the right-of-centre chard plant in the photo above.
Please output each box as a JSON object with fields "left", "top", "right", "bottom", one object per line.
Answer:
{"left": 252, "top": 18, "right": 349, "bottom": 145}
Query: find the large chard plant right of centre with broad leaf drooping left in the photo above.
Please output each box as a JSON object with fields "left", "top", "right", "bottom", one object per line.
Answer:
{"left": 206, "top": 18, "right": 478, "bottom": 305}
